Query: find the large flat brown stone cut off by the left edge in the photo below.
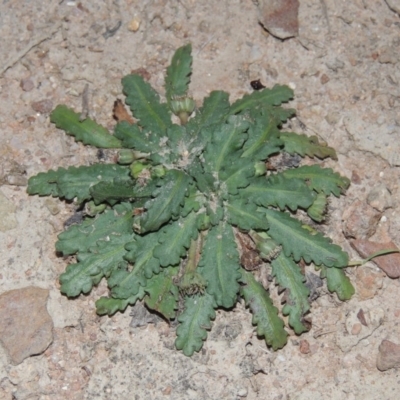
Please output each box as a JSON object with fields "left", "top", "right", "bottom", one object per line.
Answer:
{"left": 0, "top": 287, "right": 53, "bottom": 365}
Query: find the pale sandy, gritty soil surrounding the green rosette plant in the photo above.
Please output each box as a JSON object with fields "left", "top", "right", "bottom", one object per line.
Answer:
{"left": 0, "top": 0, "right": 400, "bottom": 400}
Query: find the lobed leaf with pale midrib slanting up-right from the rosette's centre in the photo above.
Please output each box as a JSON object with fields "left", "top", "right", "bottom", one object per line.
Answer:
{"left": 203, "top": 116, "right": 249, "bottom": 174}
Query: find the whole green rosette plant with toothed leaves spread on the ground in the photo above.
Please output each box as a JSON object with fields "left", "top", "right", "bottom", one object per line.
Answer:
{"left": 28, "top": 45, "right": 354, "bottom": 356}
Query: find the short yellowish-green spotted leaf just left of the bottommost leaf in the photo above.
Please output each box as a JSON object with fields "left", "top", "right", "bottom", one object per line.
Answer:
{"left": 144, "top": 267, "right": 179, "bottom": 320}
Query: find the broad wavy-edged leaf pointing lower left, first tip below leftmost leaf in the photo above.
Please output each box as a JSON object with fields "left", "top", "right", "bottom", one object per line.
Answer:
{"left": 56, "top": 203, "right": 133, "bottom": 255}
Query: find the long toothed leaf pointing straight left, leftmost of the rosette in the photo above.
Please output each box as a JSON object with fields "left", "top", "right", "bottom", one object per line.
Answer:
{"left": 28, "top": 164, "right": 129, "bottom": 203}
